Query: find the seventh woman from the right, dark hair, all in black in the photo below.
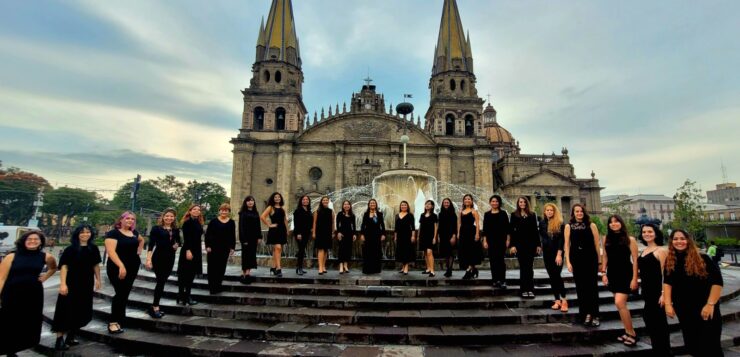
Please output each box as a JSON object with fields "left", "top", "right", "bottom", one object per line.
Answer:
{"left": 483, "top": 195, "right": 511, "bottom": 289}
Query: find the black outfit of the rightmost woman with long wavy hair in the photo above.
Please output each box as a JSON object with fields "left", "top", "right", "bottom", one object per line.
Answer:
{"left": 664, "top": 252, "right": 723, "bottom": 356}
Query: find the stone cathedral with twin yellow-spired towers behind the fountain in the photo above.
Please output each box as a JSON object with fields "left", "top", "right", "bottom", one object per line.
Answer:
{"left": 231, "top": 0, "right": 602, "bottom": 216}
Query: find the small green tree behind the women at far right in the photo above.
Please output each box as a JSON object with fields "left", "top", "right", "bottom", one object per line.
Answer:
{"left": 671, "top": 179, "right": 706, "bottom": 240}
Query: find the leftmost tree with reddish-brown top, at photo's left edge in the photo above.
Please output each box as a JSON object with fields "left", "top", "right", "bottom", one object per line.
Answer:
{"left": 0, "top": 161, "right": 51, "bottom": 226}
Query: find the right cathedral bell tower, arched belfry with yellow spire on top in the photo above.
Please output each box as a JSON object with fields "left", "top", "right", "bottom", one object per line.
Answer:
{"left": 425, "top": 0, "right": 485, "bottom": 138}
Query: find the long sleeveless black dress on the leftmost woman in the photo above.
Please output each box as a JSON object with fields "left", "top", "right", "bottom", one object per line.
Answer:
{"left": 0, "top": 250, "right": 46, "bottom": 354}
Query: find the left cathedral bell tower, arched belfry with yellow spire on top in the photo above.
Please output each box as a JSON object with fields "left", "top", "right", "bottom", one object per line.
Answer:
{"left": 242, "top": 0, "right": 306, "bottom": 136}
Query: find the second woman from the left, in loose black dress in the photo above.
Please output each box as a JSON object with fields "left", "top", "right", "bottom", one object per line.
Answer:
{"left": 51, "top": 224, "right": 101, "bottom": 351}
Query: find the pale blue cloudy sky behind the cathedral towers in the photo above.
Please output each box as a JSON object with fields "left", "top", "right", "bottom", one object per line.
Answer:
{"left": 0, "top": 0, "right": 740, "bottom": 196}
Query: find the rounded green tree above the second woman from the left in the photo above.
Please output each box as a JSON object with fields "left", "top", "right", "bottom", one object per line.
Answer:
{"left": 42, "top": 187, "right": 98, "bottom": 237}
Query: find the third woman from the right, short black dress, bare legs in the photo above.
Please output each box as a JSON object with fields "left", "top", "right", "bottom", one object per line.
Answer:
{"left": 601, "top": 215, "right": 638, "bottom": 347}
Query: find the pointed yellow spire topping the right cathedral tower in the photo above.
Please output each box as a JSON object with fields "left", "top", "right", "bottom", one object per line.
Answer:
{"left": 434, "top": 0, "right": 472, "bottom": 74}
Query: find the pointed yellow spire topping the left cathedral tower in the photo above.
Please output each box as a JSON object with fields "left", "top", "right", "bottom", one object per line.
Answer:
{"left": 257, "top": 0, "right": 300, "bottom": 67}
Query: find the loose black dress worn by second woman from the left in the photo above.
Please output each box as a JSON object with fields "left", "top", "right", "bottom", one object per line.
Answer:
{"left": 51, "top": 244, "right": 101, "bottom": 332}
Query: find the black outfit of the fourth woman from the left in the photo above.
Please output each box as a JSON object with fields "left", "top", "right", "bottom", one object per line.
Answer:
{"left": 147, "top": 226, "right": 180, "bottom": 306}
